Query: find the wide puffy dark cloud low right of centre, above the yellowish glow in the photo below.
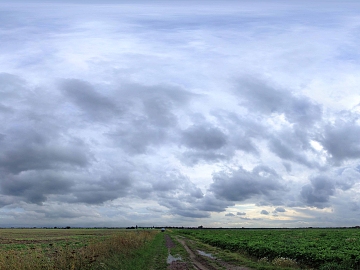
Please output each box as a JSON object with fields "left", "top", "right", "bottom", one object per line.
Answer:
{"left": 210, "top": 166, "right": 285, "bottom": 201}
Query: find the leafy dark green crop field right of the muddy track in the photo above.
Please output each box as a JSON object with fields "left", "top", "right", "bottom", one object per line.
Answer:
{"left": 178, "top": 228, "right": 360, "bottom": 270}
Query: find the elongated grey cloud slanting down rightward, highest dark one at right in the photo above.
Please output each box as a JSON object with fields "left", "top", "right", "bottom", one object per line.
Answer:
{"left": 236, "top": 78, "right": 322, "bottom": 126}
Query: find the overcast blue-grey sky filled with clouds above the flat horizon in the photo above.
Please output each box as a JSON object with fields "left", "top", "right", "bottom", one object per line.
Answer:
{"left": 0, "top": 0, "right": 360, "bottom": 228}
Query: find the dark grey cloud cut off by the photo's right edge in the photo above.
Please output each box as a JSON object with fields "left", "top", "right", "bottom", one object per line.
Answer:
{"left": 319, "top": 119, "right": 360, "bottom": 165}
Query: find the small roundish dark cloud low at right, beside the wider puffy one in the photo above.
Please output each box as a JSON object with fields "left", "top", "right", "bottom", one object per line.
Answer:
{"left": 300, "top": 176, "right": 335, "bottom": 208}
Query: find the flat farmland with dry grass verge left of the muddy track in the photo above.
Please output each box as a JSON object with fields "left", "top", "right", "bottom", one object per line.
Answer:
{"left": 0, "top": 229, "right": 166, "bottom": 270}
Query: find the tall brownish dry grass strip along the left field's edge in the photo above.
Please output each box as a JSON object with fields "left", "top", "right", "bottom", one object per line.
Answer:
{"left": 0, "top": 231, "right": 157, "bottom": 270}
